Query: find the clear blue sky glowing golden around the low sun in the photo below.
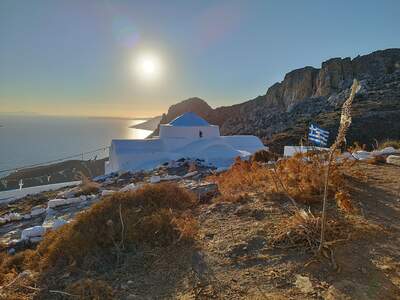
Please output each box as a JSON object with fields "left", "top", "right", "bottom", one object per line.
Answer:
{"left": 0, "top": 0, "right": 400, "bottom": 117}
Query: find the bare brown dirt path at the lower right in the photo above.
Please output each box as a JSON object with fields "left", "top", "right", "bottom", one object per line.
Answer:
{"left": 193, "top": 164, "right": 400, "bottom": 299}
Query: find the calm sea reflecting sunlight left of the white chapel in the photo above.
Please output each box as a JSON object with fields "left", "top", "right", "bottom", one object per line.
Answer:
{"left": 0, "top": 115, "right": 151, "bottom": 177}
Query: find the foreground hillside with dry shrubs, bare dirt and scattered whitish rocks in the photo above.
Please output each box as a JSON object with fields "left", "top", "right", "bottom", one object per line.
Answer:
{"left": 0, "top": 156, "right": 400, "bottom": 300}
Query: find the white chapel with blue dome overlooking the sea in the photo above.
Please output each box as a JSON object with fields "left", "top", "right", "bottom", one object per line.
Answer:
{"left": 106, "top": 112, "right": 267, "bottom": 174}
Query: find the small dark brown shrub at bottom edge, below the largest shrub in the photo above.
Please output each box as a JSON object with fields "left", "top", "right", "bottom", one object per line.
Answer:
{"left": 66, "top": 278, "right": 115, "bottom": 300}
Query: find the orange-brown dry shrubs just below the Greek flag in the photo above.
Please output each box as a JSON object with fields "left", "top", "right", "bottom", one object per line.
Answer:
{"left": 210, "top": 152, "right": 356, "bottom": 204}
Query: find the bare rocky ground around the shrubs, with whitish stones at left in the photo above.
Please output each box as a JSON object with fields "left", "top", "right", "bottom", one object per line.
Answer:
{"left": 0, "top": 155, "right": 400, "bottom": 299}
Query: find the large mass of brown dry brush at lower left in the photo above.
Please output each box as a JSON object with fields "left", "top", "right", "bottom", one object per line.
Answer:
{"left": 0, "top": 183, "right": 198, "bottom": 299}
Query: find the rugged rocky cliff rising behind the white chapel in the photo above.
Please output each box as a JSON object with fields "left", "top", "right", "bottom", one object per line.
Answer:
{"left": 155, "top": 49, "right": 400, "bottom": 151}
